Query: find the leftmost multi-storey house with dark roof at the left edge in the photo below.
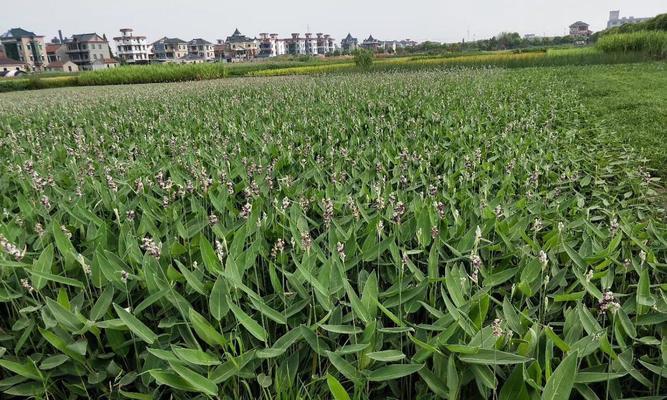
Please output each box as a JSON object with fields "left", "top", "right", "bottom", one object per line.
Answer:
{"left": 0, "top": 28, "right": 48, "bottom": 71}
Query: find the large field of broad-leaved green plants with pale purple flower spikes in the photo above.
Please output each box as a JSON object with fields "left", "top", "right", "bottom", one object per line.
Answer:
{"left": 0, "top": 68, "right": 667, "bottom": 400}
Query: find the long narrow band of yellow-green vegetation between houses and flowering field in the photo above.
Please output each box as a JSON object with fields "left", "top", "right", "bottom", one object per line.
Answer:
{"left": 0, "top": 48, "right": 656, "bottom": 92}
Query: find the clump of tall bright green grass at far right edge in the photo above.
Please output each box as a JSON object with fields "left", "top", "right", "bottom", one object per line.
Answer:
{"left": 596, "top": 31, "right": 667, "bottom": 58}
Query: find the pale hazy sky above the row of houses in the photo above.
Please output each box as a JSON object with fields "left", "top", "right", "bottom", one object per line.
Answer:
{"left": 0, "top": 0, "right": 667, "bottom": 42}
